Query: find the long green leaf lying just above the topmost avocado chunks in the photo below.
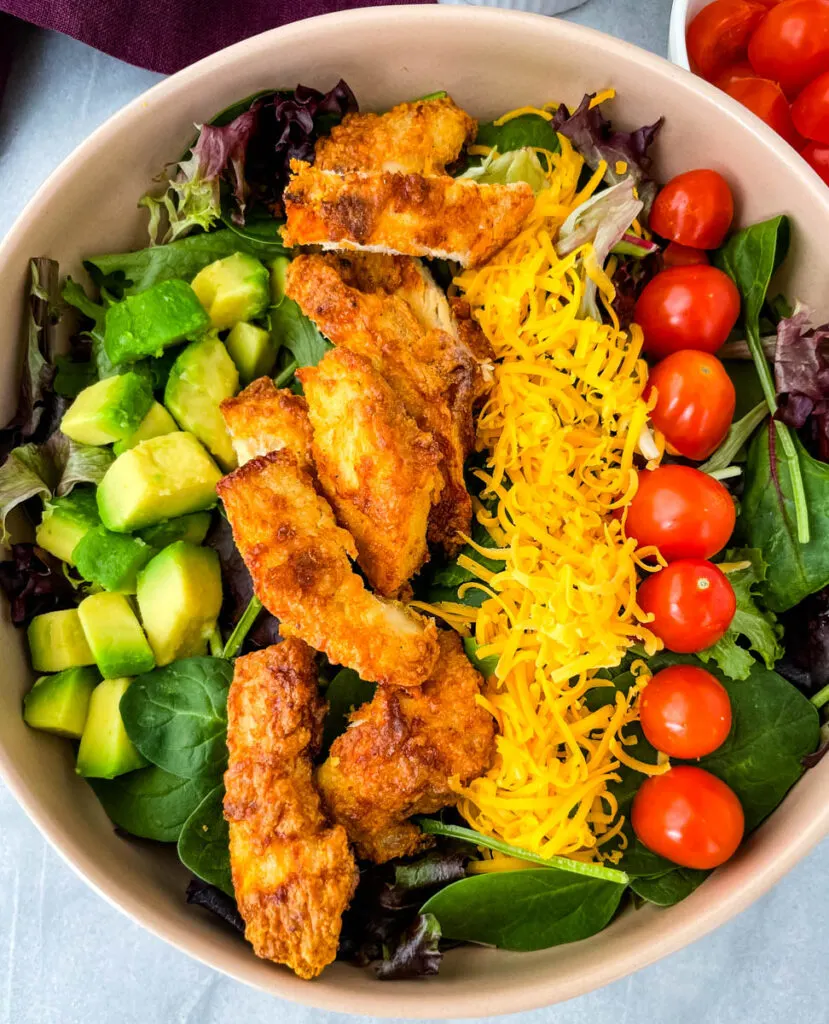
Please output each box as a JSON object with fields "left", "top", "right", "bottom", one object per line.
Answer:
{"left": 84, "top": 228, "right": 284, "bottom": 298}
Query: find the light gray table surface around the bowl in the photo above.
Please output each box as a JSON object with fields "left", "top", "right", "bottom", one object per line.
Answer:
{"left": 0, "top": 0, "right": 829, "bottom": 1024}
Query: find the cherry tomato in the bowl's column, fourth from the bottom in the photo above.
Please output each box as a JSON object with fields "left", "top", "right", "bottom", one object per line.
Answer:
{"left": 625, "top": 466, "right": 736, "bottom": 561}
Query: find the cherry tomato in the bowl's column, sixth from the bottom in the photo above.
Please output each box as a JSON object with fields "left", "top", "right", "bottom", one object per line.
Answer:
{"left": 635, "top": 266, "right": 740, "bottom": 359}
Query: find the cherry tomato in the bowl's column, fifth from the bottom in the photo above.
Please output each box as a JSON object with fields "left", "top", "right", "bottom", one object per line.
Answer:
{"left": 645, "top": 350, "right": 737, "bottom": 462}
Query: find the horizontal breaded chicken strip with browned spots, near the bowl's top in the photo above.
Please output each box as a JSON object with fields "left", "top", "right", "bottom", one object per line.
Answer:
{"left": 282, "top": 160, "right": 534, "bottom": 266}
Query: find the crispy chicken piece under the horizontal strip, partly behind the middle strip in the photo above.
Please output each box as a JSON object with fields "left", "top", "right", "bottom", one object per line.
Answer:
{"left": 286, "top": 253, "right": 492, "bottom": 554}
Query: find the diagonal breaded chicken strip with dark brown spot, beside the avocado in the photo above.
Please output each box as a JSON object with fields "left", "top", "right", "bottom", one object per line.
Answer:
{"left": 216, "top": 449, "right": 438, "bottom": 686}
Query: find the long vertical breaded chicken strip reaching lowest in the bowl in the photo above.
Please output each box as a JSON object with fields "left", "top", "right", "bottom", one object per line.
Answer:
{"left": 224, "top": 640, "right": 358, "bottom": 978}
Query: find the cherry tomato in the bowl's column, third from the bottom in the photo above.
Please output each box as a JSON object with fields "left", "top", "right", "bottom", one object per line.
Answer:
{"left": 638, "top": 558, "right": 737, "bottom": 654}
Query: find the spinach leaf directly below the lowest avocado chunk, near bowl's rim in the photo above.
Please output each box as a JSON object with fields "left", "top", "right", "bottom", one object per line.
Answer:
{"left": 87, "top": 765, "right": 216, "bottom": 843}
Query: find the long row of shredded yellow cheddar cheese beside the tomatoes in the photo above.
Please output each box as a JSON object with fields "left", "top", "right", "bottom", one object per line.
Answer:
{"left": 431, "top": 130, "right": 667, "bottom": 860}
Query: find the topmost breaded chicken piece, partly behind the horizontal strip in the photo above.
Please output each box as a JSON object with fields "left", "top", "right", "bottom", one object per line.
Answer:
{"left": 314, "top": 96, "right": 478, "bottom": 174}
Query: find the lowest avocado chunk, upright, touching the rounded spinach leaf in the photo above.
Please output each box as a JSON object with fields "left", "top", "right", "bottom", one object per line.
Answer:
{"left": 75, "top": 679, "right": 146, "bottom": 778}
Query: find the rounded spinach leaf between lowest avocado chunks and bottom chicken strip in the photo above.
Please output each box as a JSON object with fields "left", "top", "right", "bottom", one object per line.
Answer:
{"left": 121, "top": 657, "right": 233, "bottom": 784}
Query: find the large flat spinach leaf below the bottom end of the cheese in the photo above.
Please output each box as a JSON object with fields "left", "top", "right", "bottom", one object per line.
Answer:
{"left": 421, "top": 868, "right": 625, "bottom": 952}
